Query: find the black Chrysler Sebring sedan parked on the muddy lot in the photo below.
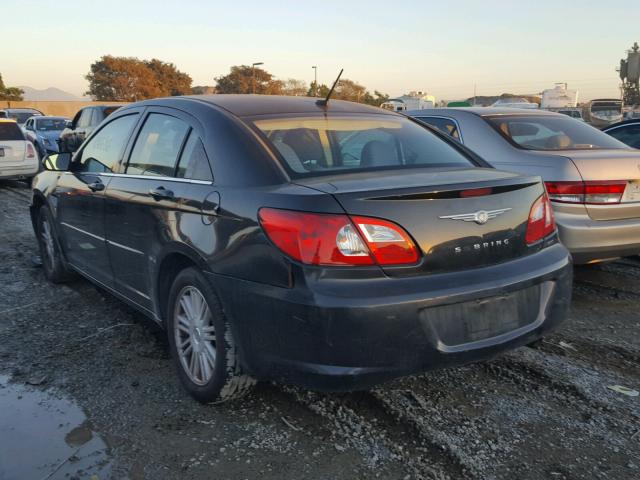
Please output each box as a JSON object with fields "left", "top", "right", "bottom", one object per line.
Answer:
{"left": 31, "top": 95, "right": 572, "bottom": 402}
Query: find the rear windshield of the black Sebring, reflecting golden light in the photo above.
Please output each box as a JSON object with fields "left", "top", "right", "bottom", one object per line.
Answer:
{"left": 254, "top": 115, "right": 473, "bottom": 176}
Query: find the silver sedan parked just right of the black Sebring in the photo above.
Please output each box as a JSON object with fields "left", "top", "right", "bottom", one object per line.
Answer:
{"left": 406, "top": 108, "right": 640, "bottom": 264}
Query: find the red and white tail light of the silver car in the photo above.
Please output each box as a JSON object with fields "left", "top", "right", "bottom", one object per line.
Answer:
{"left": 545, "top": 180, "right": 627, "bottom": 205}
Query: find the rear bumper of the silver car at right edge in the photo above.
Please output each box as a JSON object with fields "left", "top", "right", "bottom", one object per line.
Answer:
{"left": 556, "top": 209, "right": 640, "bottom": 264}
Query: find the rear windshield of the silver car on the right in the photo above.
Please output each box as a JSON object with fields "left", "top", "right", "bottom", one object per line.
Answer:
{"left": 483, "top": 115, "right": 628, "bottom": 150}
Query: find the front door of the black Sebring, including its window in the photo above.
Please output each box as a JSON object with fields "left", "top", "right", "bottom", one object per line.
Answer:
{"left": 52, "top": 113, "right": 140, "bottom": 286}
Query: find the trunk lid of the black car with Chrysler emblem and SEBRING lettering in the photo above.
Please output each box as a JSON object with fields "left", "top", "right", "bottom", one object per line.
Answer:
{"left": 298, "top": 168, "right": 543, "bottom": 276}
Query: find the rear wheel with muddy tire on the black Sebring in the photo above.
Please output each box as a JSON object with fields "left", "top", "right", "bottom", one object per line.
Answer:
{"left": 167, "top": 267, "right": 256, "bottom": 403}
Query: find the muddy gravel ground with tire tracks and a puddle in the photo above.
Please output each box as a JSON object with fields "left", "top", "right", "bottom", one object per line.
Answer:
{"left": 0, "top": 182, "right": 640, "bottom": 480}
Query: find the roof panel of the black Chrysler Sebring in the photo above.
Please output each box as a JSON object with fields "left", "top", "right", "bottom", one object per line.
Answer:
{"left": 129, "top": 94, "right": 397, "bottom": 117}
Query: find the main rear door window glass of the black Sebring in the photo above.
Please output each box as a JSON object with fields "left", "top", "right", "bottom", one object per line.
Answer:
{"left": 126, "top": 113, "right": 189, "bottom": 177}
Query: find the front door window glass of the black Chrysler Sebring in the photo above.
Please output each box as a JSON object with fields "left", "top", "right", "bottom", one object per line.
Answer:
{"left": 74, "top": 114, "right": 138, "bottom": 173}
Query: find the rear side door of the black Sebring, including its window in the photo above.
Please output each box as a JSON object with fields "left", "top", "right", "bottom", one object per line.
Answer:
{"left": 105, "top": 107, "right": 192, "bottom": 310}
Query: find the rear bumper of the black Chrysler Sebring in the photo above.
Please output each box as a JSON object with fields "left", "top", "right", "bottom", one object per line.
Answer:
{"left": 209, "top": 244, "right": 572, "bottom": 390}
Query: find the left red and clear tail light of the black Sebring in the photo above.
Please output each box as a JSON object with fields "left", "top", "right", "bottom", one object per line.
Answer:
{"left": 259, "top": 208, "right": 419, "bottom": 266}
